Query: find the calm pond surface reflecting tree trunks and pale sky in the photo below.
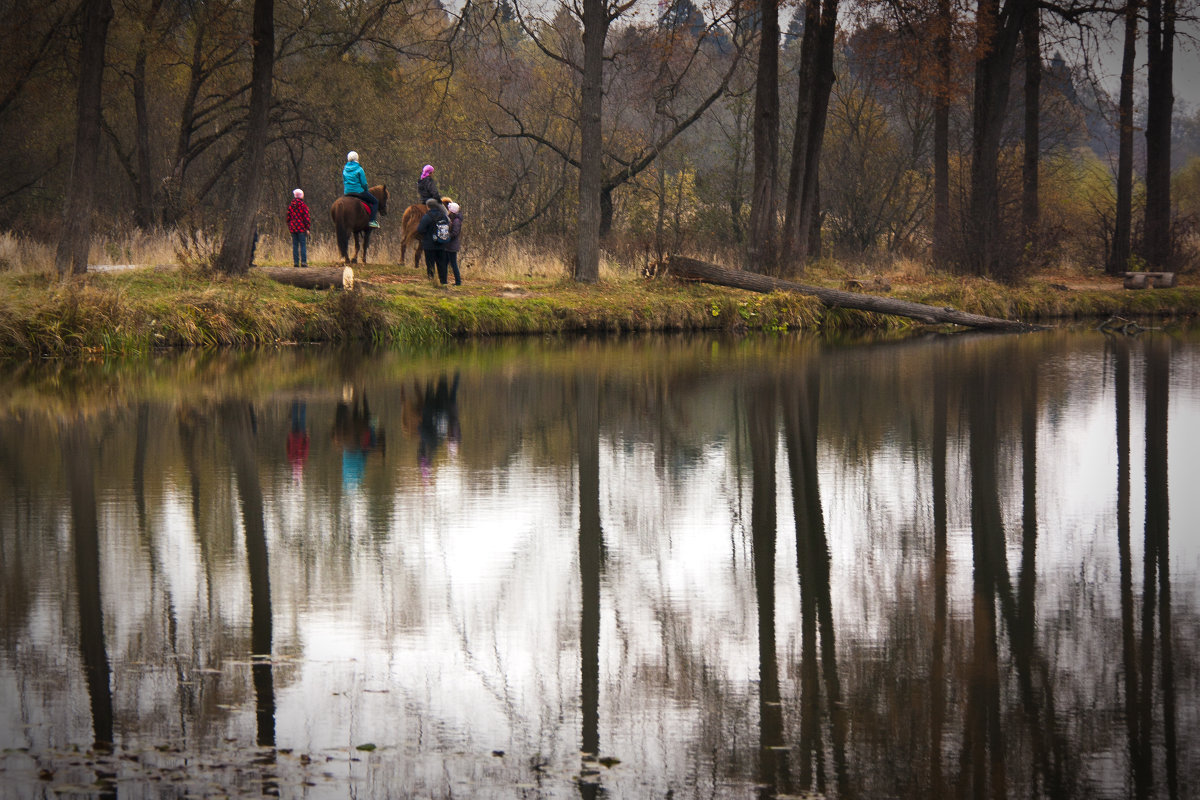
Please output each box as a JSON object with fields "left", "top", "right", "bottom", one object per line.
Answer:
{"left": 0, "top": 332, "right": 1200, "bottom": 799}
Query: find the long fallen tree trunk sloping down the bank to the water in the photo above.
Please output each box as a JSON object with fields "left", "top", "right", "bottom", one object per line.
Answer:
{"left": 668, "top": 255, "right": 1044, "bottom": 331}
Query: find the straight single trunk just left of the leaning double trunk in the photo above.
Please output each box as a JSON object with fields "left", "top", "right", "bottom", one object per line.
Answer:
{"left": 746, "top": 0, "right": 779, "bottom": 275}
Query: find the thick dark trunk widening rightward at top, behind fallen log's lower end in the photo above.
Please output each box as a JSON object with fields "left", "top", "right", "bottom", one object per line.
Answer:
{"left": 962, "top": 0, "right": 1031, "bottom": 279}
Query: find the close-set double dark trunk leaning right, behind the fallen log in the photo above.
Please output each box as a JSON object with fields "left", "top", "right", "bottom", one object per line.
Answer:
{"left": 784, "top": 0, "right": 838, "bottom": 270}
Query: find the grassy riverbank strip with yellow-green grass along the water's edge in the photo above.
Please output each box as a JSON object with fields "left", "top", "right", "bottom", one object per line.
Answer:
{"left": 0, "top": 265, "right": 1200, "bottom": 359}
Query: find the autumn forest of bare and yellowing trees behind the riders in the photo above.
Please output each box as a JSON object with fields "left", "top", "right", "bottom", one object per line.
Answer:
{"left": 0, "top": 0, "right": 1200, "bottom": 281}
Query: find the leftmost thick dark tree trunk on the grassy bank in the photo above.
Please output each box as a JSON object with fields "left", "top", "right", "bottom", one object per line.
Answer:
{"left": 54, "top": 0, "right": 113, "bottom": 277}
